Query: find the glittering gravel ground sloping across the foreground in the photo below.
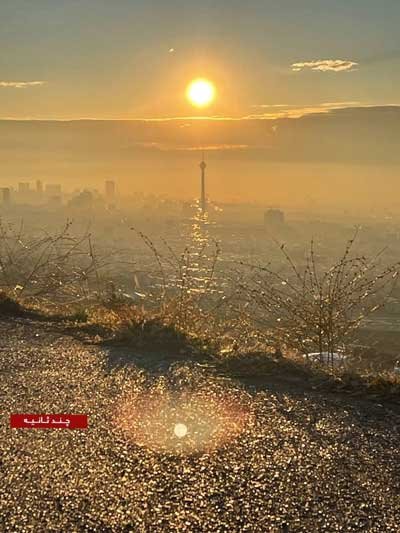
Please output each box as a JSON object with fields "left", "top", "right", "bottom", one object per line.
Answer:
{"left": 0, "top": 320, "right": 400, "bottom": 533}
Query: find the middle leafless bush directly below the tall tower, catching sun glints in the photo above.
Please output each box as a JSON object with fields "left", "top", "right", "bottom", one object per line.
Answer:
{"left": 126, "top": 224, "right": 255, "bottom": 343}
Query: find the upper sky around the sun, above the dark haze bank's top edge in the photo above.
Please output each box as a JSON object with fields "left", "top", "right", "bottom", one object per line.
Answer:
{"left": 0, "top": 0, "right": 400, "bottom": 118}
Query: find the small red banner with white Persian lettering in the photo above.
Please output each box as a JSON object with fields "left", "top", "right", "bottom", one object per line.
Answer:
{"left": 10, "top": 414, "right": 88, "bottom": 429}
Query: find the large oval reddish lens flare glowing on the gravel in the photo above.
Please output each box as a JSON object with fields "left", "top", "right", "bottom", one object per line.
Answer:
{"left": 114, "top": 366, "right": 252, "bottom": 454}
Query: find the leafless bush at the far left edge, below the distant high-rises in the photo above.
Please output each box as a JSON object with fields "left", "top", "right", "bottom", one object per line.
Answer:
{"left": 0, "top": 221, "right": 109, "bottom": 304}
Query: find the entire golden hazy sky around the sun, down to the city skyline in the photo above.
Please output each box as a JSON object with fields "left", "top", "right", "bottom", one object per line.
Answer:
{"left": 0, "top": 0, "right": 400, "bottom": 205}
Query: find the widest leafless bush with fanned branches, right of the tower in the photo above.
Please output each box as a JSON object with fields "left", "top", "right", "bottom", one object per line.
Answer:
{"left": 242, "top": 232, "right": 399, "bottom": 364}
